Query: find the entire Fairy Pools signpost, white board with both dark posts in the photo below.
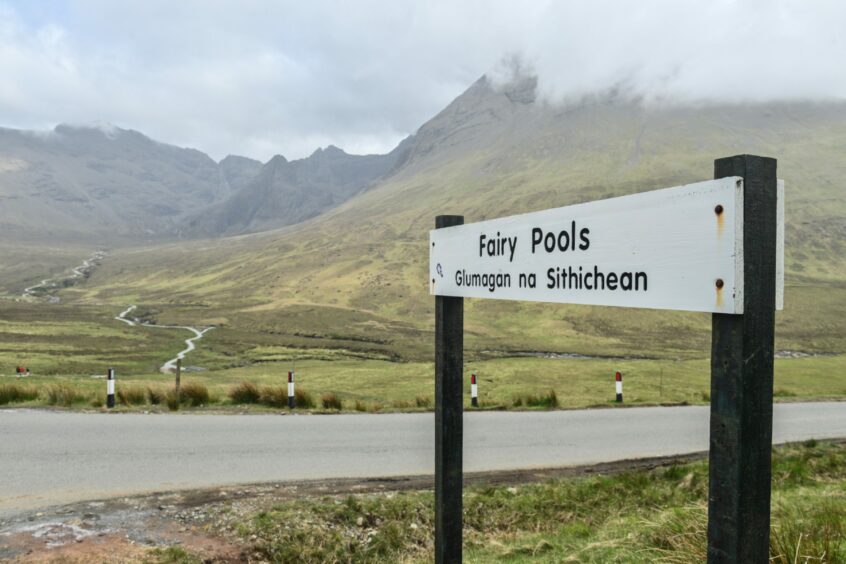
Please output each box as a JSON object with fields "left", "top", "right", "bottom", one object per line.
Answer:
{"left": 429, "top": 155, "right": 784, "bottom": 563}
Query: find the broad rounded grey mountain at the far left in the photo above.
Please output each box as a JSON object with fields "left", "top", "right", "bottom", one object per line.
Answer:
{"left": 0, "top": 125, "right": 231, "bottom": 242}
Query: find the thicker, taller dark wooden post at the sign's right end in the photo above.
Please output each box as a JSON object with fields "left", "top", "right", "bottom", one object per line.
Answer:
{"left": 708, "top": 155, "right": 777, "bottom": 564}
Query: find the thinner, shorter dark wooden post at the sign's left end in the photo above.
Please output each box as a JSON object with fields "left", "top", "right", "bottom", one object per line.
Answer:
{"left": 435, "top": 215, "right": 464, "bottom": 564}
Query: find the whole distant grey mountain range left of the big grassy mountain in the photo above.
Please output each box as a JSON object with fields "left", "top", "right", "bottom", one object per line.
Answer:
{"left": 0, "top": 125, "right": 408, "bottom": 242}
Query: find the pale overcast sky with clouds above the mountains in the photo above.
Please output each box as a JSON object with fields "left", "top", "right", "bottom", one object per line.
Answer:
{"left": 0, "top": 0, "right": 846, "bottom": 160}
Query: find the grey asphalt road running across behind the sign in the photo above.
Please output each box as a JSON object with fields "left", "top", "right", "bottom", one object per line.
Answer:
{"left": 0, "top": 403, "right": 846, "bottom": 516}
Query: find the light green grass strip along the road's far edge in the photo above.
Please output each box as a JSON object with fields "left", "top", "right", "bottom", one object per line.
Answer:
{"left": 0, "top": 350, "right": 846, "bottom": 411}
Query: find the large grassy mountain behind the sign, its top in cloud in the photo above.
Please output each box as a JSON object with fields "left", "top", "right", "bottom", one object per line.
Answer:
{"left": 53, "top": 77, "right": 846, "bottom": 359}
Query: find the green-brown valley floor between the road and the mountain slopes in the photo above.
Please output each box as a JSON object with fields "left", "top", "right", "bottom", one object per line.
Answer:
{"left": 0, "top": 262, "right": 846, "bottom": 412}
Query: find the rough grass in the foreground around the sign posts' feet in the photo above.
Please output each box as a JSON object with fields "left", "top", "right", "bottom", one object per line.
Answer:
{"left": 237, "top": 442, "right": 846, "bottom": 564}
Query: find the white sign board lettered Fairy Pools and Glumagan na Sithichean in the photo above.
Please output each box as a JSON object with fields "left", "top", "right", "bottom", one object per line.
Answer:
{"left": 429, "top": 177, "right": 784, "bottom": 314}
